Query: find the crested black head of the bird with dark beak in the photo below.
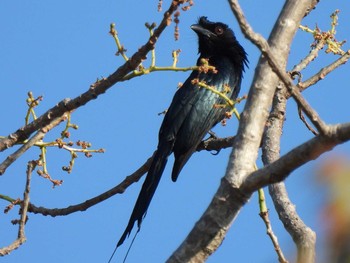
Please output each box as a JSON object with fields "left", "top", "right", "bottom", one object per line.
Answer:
{"left": 191, "top": 16, "right": 247, "bottom": 68}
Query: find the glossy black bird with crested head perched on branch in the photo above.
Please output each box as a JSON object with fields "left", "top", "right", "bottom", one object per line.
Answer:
{"left": 113, "top": 16, "right": 248, "bottom": 256}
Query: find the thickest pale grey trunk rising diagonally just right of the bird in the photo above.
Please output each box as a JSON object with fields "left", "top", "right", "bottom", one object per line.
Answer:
{"left": 168, "top": 0, "right": 311, "bottom": 262}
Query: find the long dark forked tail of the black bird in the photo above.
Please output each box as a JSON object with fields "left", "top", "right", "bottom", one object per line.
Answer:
{"left": 108, "top": 145, "right": 171, "bottom": 262}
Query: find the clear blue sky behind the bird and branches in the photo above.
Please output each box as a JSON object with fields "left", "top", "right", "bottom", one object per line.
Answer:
{"left": 0, "top": 0, "right": 350, "bottom": 263}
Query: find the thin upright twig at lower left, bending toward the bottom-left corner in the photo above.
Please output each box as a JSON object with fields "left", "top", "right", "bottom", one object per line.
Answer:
{"left": 0, "top": 161, "right": 35, "bottom": 256}
